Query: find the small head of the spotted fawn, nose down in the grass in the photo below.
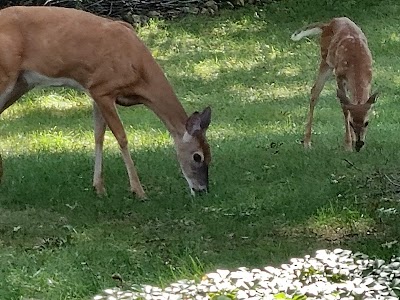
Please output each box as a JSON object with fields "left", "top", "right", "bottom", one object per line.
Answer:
{"left": 337, "top": 89, "right": 378, "bottom": 152}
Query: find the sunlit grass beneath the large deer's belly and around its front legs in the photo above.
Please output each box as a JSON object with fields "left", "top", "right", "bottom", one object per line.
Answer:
{"left": 0, "top": 89, "right": 175, "bottom": 155}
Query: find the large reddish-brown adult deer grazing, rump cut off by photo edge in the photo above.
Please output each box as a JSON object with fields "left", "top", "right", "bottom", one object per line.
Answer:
{"left": 0, "top": 6, "right": 211, "bottom": 198}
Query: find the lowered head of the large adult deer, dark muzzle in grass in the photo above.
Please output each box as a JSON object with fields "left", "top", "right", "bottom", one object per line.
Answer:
{"left": 176, "top": 107, "right": 211, "bottom": 195}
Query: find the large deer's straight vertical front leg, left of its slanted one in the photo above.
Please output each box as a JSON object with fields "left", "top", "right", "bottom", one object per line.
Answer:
{"left": 93, "top": 102, "right": 106, "bottom": 196}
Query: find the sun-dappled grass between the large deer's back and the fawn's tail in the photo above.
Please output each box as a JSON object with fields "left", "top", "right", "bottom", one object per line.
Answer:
{"left": 139, "top": 18, "right": 293, "bottom": 78}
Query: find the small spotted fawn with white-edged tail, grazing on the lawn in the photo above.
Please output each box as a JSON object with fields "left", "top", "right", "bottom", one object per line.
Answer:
{"left": 292, "top": 18, "right": 378, "bottom": 152}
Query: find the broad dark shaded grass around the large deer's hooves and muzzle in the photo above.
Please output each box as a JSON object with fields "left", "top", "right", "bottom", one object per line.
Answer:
{"left": 0, "top": 126, "right": 400, "bottom": 267}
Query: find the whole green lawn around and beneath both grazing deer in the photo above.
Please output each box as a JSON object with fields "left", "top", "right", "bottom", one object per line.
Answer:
{"left": 0, "top": 0, "right": 400, "bottom": 299}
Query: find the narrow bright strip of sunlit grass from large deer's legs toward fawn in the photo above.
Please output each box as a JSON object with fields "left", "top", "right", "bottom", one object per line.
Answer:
{"left": 1, "top": 119, "right": 301, "bottom": 156}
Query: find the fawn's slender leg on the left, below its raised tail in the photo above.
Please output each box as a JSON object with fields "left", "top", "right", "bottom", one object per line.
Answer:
{"left": 304, "top": 61, "right": 332, "bottom": 148}
